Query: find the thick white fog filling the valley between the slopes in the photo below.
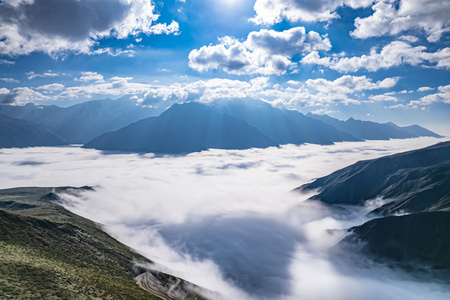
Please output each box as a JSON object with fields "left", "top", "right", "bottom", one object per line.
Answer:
{"left": 0, "top": 138, "right": 450, "bottom": 299}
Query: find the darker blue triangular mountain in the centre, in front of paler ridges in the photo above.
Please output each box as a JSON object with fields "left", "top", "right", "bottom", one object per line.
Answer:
{"left": 83, "top": 102, "right": 278, "bottom": 153}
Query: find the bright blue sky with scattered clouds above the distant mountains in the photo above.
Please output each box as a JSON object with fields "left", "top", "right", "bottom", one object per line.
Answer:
{"left": 0, "top": 0, "right": 450, "bottom": 134}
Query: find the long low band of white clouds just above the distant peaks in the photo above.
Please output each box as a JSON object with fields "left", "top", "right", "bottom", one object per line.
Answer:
{"left": 6, "top": 72, "right": 399, "bottom": 111}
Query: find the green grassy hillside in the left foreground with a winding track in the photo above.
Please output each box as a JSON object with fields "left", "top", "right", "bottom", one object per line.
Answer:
{"left": 0, "top": 187, "right": 212, "bottom": 300}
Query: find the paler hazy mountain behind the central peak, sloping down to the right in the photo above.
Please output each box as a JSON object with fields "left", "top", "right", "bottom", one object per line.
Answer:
{"left": 210, "top": 99, "right": 360, "bottom": 145}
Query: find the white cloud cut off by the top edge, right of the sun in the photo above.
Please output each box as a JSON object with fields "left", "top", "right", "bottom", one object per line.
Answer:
{"left": 252, "top": 0, "right": 373, "bottom": 25}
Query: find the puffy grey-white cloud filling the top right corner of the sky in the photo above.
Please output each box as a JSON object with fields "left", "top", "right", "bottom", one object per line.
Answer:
{"left": 351, "top": 0, "right": 450, "bottom": 42}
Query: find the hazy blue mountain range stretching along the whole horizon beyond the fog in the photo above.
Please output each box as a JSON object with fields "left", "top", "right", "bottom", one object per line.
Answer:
{"left": 0, "top": 98, "right": 440, "bottom": 153}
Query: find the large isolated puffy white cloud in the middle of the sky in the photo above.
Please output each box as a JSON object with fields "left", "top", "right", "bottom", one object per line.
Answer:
{"left": 189, "top": 27, "right": 331, "bottom": 75}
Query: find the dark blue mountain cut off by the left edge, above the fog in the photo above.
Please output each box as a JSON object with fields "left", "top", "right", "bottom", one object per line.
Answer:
{"left": 0, "top": 114, "right": 65, "bottom": 148}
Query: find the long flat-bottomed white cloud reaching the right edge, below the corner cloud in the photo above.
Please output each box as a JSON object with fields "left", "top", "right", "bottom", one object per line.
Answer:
{"left": 301, "top": 41, "right": 450, "bottom": 72}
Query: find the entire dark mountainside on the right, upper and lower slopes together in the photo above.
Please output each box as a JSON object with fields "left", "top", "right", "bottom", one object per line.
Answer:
{"left": 296, "top": 142, "right": 450, "bottom": 278}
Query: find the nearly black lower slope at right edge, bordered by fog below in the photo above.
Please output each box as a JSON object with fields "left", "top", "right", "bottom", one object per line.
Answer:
{"left": 333, "top": 212, "right": 450, "bottom": 277}
